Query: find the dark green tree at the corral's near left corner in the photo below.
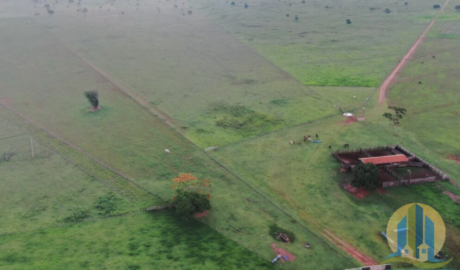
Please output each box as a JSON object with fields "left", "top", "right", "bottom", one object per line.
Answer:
{"left": 351, "top": 163, "right": 380, "bottom": 190}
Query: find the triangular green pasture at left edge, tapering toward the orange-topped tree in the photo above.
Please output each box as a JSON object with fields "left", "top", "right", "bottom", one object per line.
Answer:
{"left": 0, "top": 112, "right": 149, "bottom": 234}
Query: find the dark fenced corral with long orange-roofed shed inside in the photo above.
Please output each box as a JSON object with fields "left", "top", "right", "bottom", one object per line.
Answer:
{"left": 332, "top": 145, "right": 449, "bottom": 187}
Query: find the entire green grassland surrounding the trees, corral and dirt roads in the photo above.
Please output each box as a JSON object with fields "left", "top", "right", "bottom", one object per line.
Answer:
{"left": 0, "top": 0, "right": 460, "bottom": 269}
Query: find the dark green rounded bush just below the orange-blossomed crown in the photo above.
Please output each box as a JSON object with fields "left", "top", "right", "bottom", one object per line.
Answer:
{"left": 174, "top": 190, "right": 211, "bottom": 220}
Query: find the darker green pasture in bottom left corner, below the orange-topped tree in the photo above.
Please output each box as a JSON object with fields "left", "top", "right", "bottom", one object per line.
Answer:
{"left": 0, "top": 211, "right": 274, "bottom": 269}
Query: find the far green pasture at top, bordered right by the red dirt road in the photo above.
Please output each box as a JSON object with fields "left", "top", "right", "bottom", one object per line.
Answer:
{"left": 200, "top": 0, "right": 444, "bottom": 87}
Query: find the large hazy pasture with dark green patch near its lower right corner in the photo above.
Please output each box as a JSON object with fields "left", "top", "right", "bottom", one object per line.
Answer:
{"left": 26, "top": 2, "right": 336, "bottom": 148}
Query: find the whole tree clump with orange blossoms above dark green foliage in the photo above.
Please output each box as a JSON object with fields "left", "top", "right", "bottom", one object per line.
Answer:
{"left": 172, "top": 173, "right": 211, "bottom": 220}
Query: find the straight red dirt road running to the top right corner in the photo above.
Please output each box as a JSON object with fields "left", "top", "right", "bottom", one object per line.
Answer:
{"left": 379, "top": 0, "right": 450, "bottom": 104}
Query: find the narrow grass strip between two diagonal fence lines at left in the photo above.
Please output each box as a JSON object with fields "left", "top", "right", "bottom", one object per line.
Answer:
{"left": 0, "top": 105, "right": 160, "bottom": 206}
